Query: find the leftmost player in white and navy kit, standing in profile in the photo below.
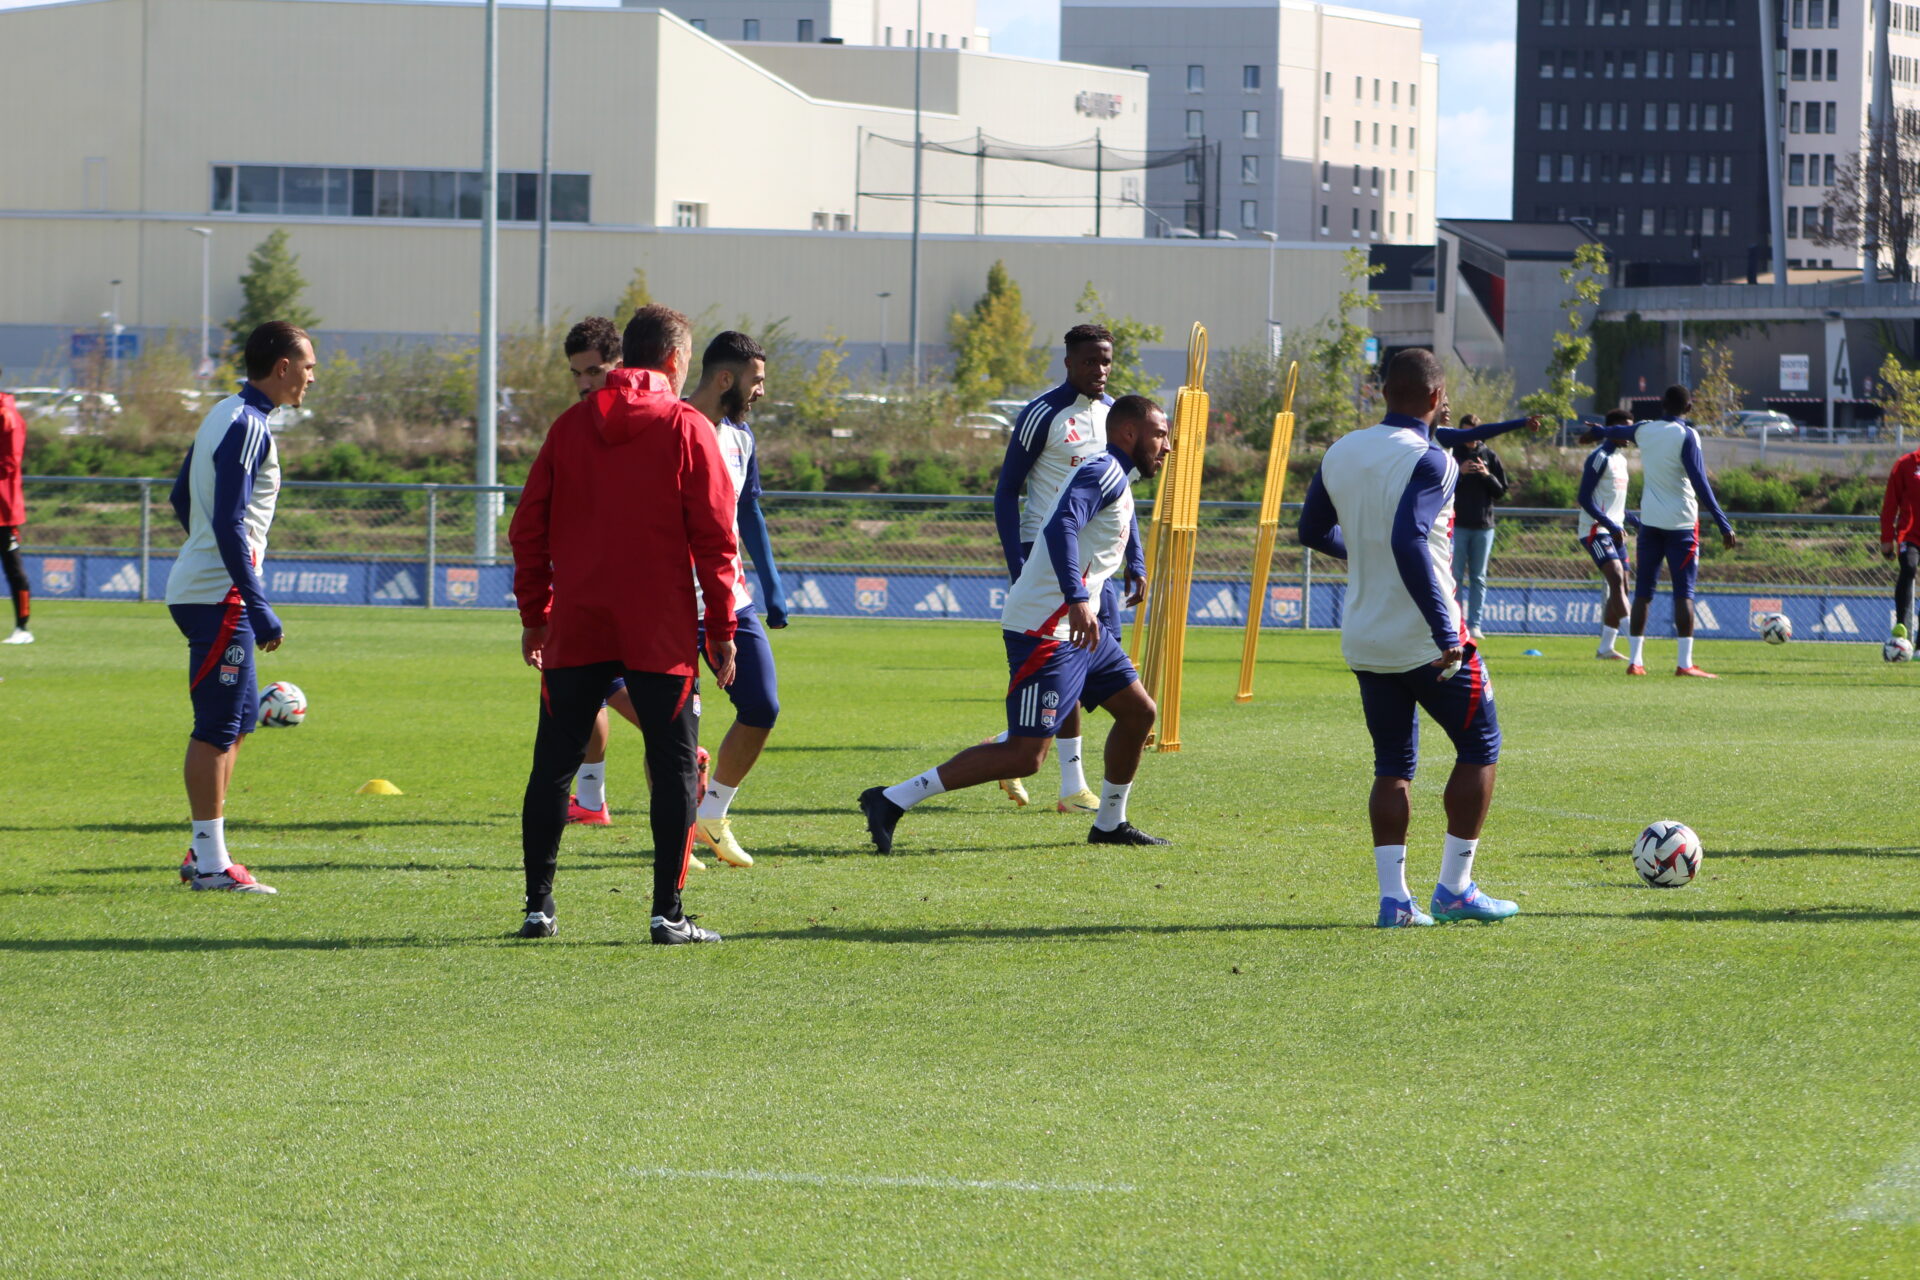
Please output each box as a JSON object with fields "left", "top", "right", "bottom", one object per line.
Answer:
{"left": 167, "top": 320, "right": 315, "bottom": 894}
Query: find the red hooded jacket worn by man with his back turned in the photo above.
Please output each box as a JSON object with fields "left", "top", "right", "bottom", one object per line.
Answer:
{"left": 509, "top": 368, "right": 735, "bottom": 676}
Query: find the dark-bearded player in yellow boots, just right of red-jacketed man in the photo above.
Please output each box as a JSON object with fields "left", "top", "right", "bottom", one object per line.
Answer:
{"left": 687, "top": 330, "right": 787, "bottom": 867}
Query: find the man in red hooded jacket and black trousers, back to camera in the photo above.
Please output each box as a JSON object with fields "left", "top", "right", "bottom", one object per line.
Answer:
{"left": 509, "top": 305, "right": 735, "bottom": 944}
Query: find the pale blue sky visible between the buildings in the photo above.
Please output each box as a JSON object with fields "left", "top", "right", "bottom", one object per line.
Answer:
{"left": 0, "top": 0, "right": 1515, "bottom": 219}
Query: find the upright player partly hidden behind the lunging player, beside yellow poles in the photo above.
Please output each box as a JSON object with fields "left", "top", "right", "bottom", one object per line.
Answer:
{"left": 993, "top": 324, "right": 1146, "bottom": 814}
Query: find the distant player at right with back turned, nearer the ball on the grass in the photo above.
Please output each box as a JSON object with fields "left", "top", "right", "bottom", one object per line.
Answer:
{"left": 1588, "top": 382, "right": 1740, "bottom": 679}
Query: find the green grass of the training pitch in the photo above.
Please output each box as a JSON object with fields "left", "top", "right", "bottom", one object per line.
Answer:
{"left": 0, "top": 604, "right": 1920, "bottom": 1278}
